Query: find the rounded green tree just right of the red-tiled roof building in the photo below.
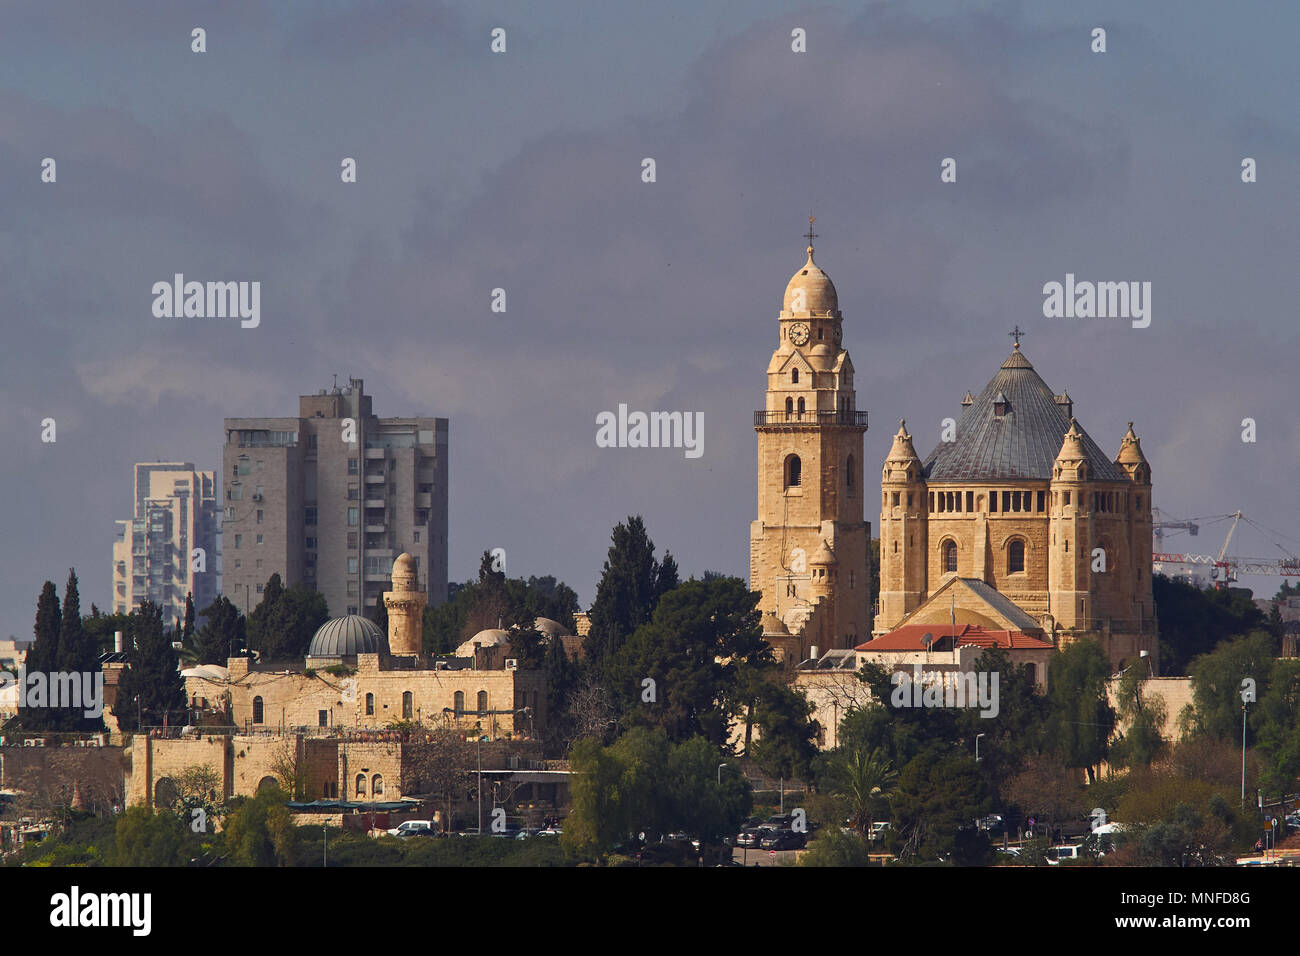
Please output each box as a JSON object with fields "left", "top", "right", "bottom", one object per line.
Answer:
{"left": 1047, "top": 640, "right": 1115, "bottom": 782}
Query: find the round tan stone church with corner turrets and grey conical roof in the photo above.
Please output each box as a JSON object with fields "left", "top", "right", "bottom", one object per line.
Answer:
{"left": 875, "top": 338, "right": 1157, "bottom": 667}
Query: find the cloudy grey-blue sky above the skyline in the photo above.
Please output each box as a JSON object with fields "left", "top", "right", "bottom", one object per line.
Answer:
{"left": 0, "top": 0, "right": 1300, "bottom": 637}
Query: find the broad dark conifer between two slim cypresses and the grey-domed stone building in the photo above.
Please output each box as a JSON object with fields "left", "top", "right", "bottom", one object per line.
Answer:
{"left": 113, "top": 601, "right": 186, "bottom": 731}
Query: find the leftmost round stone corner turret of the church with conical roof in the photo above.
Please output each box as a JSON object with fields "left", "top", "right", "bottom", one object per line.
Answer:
{"left": 874, "top": 421, "right": 930, "bottom": 633}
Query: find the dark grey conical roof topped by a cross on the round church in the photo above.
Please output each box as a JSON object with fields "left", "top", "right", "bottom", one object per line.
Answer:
{"left": 926, "top": 345, "right": 1126, "bottom": 481}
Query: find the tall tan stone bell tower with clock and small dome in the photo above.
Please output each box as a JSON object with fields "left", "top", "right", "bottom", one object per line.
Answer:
{"left": 749, "top": 217, "right": 871, "bottom": 654}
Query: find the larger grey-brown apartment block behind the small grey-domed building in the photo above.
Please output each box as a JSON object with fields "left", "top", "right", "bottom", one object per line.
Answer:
{"left": 221, "top": 378, "right": 447, "bottom": 617}
